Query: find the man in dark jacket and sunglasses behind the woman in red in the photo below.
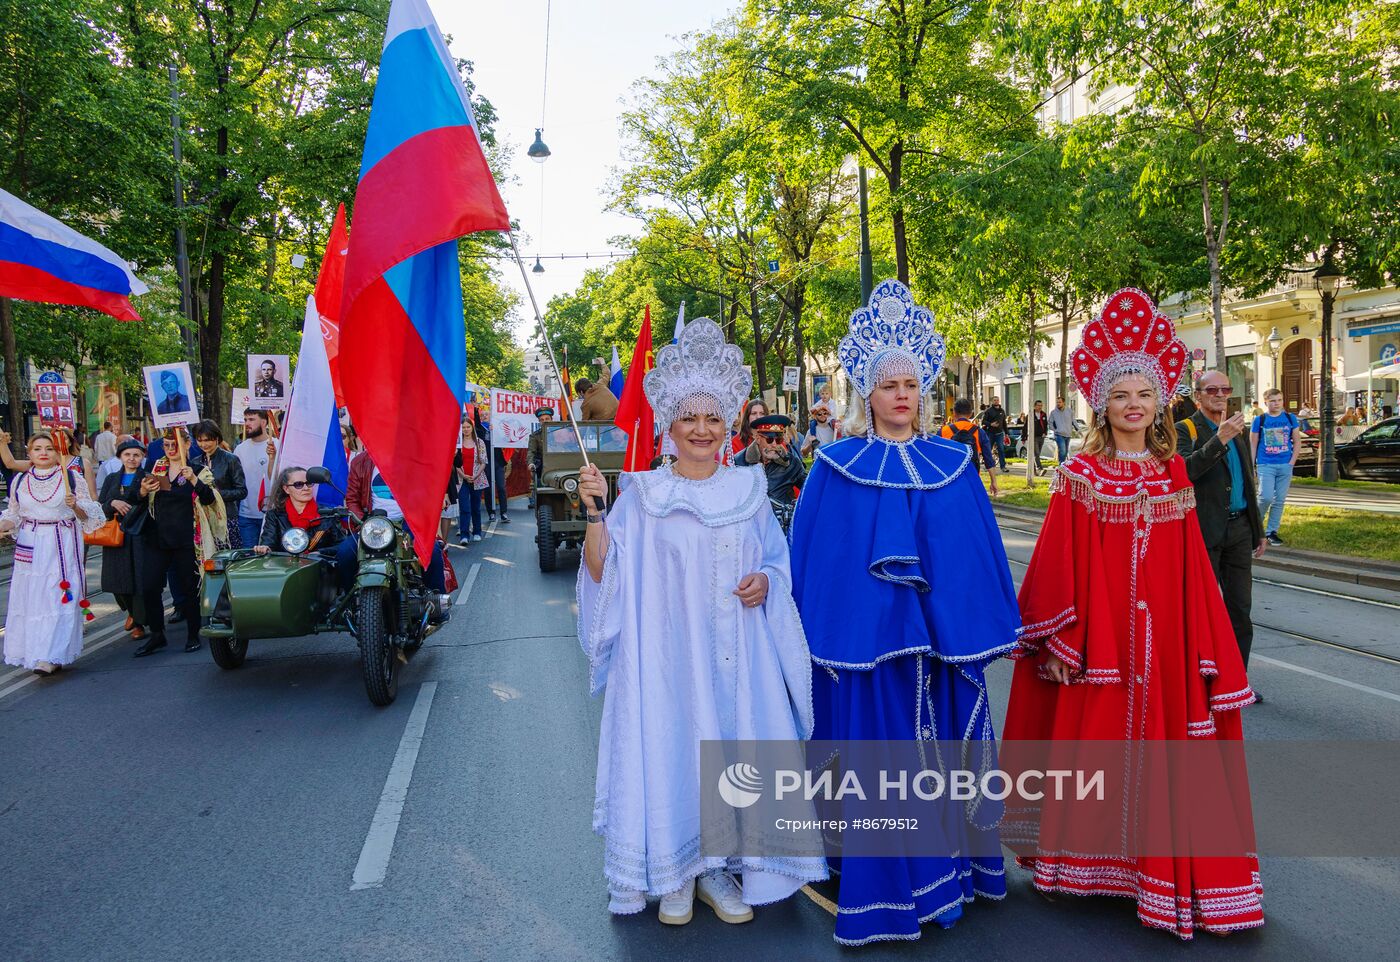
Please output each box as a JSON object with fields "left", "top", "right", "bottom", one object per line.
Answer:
{"left": 1176, "top": 371, "right": 1268, "bottom": 669}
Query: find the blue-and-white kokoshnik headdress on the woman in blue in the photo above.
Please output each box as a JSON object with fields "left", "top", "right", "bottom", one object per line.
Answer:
{"left": 837, "top": 280, "right": 946, "bottom": 433}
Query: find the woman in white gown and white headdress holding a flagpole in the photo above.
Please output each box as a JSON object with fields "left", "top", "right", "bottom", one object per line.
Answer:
{"left": 578, "top": 318, "right": 826, "bottom": 924}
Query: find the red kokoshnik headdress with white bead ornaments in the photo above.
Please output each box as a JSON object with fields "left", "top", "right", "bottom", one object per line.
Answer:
{"left": 1070, "top": 287, "right": 1189, "bottom": 414}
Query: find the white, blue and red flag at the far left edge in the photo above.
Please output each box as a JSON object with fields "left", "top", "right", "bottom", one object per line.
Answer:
{"left": 0, "top": 190, "right": 147, "bottom": 321}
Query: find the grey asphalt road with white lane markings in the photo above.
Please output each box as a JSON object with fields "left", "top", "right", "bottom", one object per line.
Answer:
{"left": 0, "top": 503, "right": 1400, "bottom": 962}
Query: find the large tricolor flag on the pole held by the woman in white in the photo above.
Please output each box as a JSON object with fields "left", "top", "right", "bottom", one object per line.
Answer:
{"left": 339, "top": 0, "right": 510, "bottom": 564}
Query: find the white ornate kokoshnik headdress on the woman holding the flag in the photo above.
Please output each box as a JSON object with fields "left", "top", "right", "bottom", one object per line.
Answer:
{"left": 641, "top": 318, "right": 753, "bottom": 430}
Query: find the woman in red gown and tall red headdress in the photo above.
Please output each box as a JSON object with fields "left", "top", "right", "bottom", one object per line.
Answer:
{"left": 1002, "top": 290, "right": 1264, "bottom": 938}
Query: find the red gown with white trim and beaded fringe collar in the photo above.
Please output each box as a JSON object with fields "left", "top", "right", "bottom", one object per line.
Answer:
{"left": 1002, "top": 455, "right": 1264, "bottom": 938}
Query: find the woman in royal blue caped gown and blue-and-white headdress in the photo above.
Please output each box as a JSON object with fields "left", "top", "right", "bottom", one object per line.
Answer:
{"left": 792, "top": 280, "right": 1021, "bottom": 945}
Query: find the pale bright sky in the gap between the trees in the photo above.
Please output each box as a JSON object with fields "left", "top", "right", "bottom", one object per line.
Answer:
{"left": 430, "top": 0, "right": 739, "bottom": 338}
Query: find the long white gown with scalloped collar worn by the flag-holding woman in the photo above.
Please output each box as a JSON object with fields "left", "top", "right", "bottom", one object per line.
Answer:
{"left": 578, "top": 466, "right": 827, "bottom": 907}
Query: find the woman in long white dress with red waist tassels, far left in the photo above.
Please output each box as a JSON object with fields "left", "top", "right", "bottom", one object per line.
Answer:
{"left": 0, "top": 433, "right": 104, "bottom": 675}
